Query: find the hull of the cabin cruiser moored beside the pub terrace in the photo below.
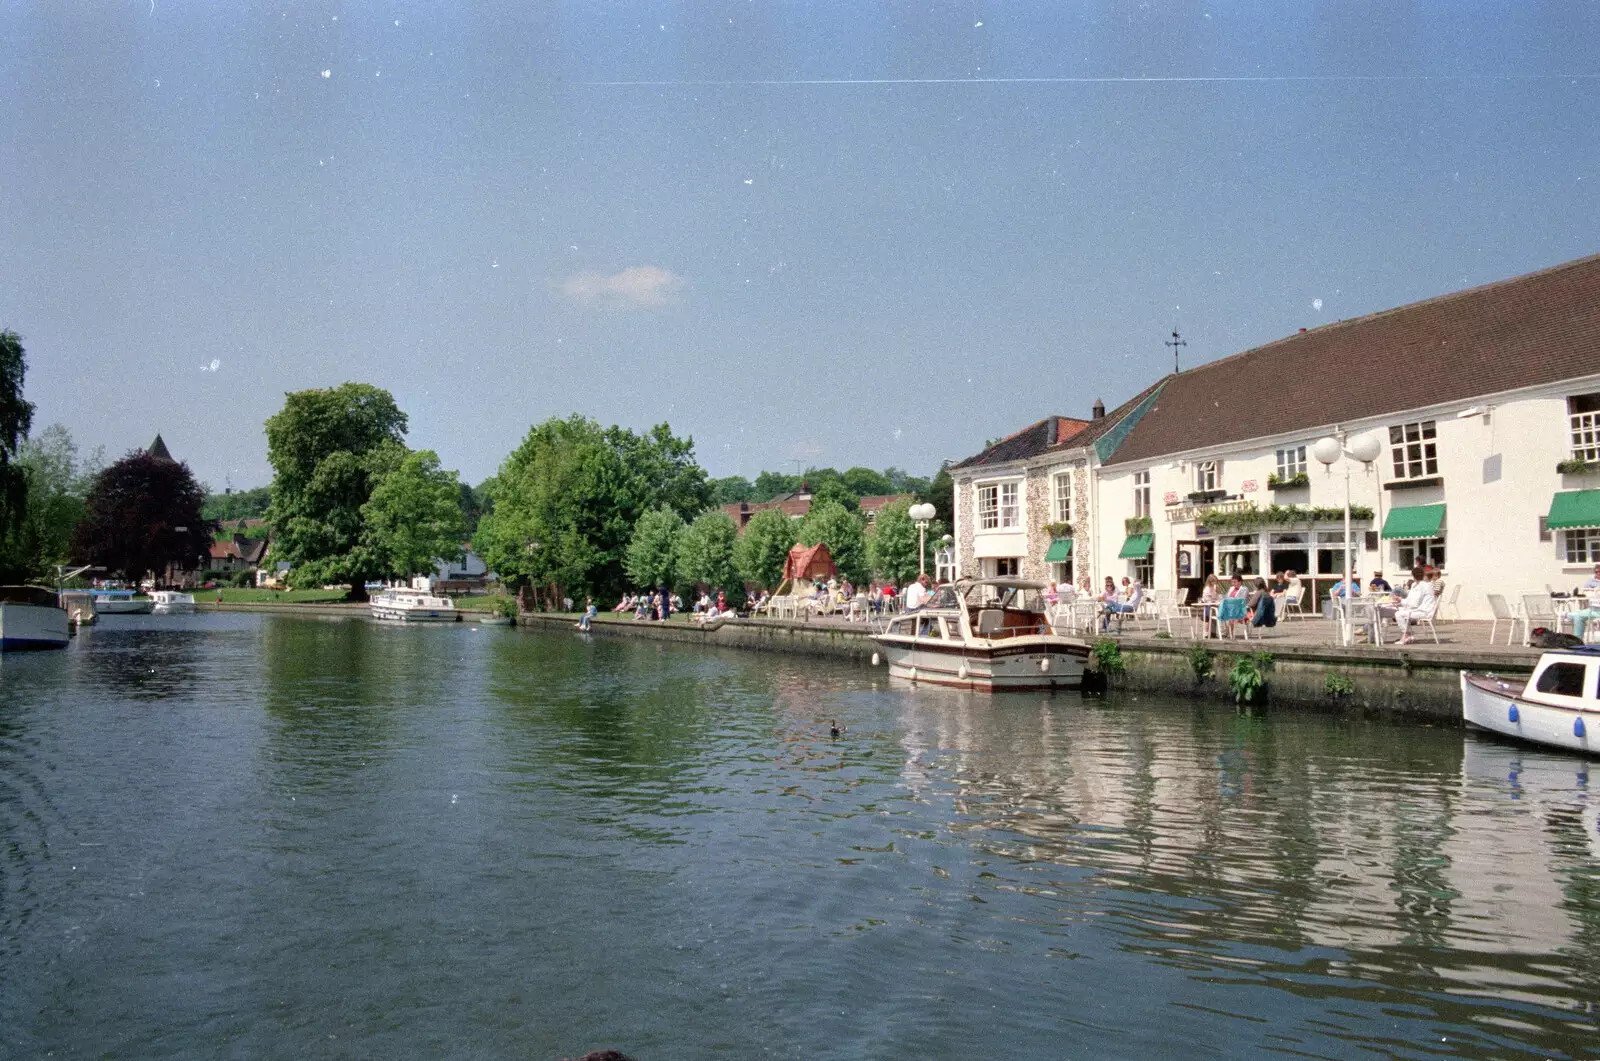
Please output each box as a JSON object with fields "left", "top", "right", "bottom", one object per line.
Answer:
{"left": 875, "top": 637, "right": 1090, "bottom": 693}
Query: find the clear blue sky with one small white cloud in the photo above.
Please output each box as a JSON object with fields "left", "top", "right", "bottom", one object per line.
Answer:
{"left": 0, "top": 0, "right": 1600, "bottom": 488}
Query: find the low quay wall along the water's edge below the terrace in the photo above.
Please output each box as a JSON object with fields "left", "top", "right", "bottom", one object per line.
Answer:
{"left": 517, "top": 613, "right": 1534, "bottom": 725}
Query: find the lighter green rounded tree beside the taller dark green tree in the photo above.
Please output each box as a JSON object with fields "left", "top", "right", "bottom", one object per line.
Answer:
{"left": 362, "top": 450, "right": 464, "bottom": 578}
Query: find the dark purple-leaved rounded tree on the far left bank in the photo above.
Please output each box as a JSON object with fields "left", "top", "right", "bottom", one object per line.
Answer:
{"left": 72, "top": 450, "right": 218, "bottom": 579}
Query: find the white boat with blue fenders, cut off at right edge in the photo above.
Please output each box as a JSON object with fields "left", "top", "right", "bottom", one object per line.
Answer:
{"left": 1461, "top": 645, "right": 1600, "bottom": 755}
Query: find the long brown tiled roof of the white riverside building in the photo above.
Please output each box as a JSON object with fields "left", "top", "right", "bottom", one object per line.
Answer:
{"left": 1106, "top": 254, "right": 1600, "bottom": 464}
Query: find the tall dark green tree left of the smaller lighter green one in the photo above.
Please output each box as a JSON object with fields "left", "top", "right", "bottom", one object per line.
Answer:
{"left": 267, "top": 382, "right": 406, "bottom": 600}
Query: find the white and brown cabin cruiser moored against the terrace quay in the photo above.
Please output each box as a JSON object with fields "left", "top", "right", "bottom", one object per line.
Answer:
{"left": 874, "top": 578, "right": 1090, "bottom": 693}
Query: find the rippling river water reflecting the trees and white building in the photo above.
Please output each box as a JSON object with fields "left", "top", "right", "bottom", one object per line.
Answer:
{"left": 0, "top": 615, "right": 1600, "bottom": 1061}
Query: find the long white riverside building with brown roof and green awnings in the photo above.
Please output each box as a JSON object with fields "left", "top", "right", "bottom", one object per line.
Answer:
{"left": 950, "top": 249, "right": 1600, "bottom": 618}
